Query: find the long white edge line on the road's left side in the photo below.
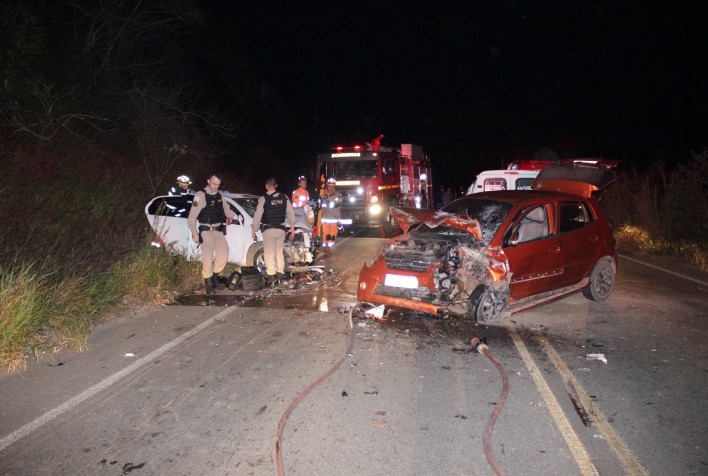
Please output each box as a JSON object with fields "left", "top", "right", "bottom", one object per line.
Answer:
{"left": 0, "top": 307, "right": 236, "bottom": 451}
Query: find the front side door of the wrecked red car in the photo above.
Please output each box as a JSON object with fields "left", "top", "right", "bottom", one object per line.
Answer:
{"left": 503, "top": 203, "right": 563, "bottom": 300}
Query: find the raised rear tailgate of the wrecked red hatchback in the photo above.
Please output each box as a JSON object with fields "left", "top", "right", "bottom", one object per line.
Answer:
{"left": 531, "top": 159, "right": 619, "bottom": 198}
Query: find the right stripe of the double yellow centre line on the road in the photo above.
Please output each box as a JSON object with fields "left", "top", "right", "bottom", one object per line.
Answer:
{"left": 539, "top": 337, "right": 649, "bottom": 476}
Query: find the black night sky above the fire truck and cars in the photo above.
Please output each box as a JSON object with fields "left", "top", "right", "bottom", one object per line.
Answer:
{"left": 195, "top": 0, "right": 708, "bottom": 187}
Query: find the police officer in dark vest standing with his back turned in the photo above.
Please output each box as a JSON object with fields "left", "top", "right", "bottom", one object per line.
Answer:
{"left": 251, "top": 177, "right": 295, "bottom": 286}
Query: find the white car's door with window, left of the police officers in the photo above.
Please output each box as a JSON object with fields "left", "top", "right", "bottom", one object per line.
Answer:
{"left": 145, "top": 195, "right": 201, "bottom": 259}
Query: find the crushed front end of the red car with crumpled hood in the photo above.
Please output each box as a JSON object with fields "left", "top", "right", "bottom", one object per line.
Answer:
{"left": 357, "top": 208, "right": 509, "bottom": 316}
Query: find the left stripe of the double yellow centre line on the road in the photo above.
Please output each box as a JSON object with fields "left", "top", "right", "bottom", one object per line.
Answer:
{"left": 507, "top": 325, "right": 600, "bottom": 476}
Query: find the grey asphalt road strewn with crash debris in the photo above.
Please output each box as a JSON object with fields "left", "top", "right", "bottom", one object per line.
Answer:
{"left": 0, "top": 232, "right": 708, "bottom": 475}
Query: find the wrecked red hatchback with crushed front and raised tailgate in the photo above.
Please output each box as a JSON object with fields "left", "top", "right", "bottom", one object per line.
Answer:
{"left": 357, "top": 159, "right": 617, "bottom": 321}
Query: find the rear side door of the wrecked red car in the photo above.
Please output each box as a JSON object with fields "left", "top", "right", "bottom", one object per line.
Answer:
{"left": 558, "top": 199, "right": 603, "bottom": 286}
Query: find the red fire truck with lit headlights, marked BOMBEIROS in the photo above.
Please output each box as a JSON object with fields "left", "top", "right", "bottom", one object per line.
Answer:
{"left": 316, "top": 144, "right": 433, "bottom": 232}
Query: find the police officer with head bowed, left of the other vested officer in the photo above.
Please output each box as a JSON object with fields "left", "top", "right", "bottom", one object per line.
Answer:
{"left": 187, "top": 174, "right": 235, "bottom": 296}
